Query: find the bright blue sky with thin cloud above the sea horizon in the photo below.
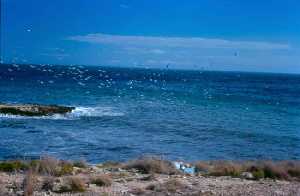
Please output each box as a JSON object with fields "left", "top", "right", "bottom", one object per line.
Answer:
{"left": 0, "top": 0, "right": 300, "bottom": 73}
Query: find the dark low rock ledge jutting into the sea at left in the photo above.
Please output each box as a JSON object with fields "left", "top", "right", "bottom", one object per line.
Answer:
{"left": 0, "top": 103, "right": 75, "bottom": 116}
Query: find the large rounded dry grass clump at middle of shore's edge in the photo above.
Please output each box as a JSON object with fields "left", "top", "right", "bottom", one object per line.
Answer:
{"left": 124, "top": 157, "right": 180, "bottom": 175}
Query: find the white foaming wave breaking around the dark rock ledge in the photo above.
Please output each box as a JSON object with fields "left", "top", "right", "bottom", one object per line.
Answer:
{"left": 0, "top": 106, "right": 124, "bottom": 120}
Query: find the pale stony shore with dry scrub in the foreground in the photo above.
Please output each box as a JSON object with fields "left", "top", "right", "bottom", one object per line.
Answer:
{"left": 0, "top": 157, "right": 300, "bottom": 196}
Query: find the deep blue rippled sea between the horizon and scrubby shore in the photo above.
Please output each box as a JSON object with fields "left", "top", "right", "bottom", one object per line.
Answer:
{"left": 0, "top": 65, "right": 300, "bottom": 163}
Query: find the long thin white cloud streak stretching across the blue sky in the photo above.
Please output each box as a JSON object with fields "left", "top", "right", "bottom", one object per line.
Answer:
{"left": 67, "top": 33, "right": 291, "bottom": 50}
